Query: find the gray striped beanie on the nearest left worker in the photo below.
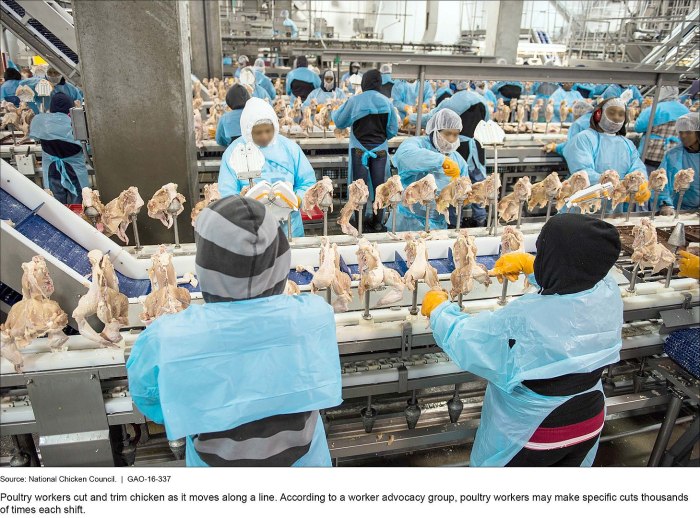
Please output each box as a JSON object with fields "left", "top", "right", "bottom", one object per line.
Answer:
{"left": 195, "top": 196, "right": 291, "bottom": 302}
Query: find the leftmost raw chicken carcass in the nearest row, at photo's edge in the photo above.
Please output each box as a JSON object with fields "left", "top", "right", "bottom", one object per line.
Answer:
{"left": 0, "top": 255, "right": 68, "bottom": 373}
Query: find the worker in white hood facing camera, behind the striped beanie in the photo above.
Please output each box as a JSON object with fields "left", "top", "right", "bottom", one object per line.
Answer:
{"left": 219, "top": 98, "right": 316, "bottom": 237}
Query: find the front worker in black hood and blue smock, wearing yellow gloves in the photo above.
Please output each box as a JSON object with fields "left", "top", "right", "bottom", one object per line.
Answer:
{"left": 421, "top": 214, "right": 623, "bottom": 467}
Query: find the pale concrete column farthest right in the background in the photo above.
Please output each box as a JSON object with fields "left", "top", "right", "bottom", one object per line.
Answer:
{"left": 484, "top": 0, "right": 524, "bottom": 65}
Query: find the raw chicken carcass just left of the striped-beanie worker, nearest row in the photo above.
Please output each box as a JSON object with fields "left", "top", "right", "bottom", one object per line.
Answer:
{"left": 140, "top": 245, "right": 191, "bottom": 325}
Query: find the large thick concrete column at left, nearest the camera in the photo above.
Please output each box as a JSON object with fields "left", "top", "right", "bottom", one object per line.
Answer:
{"left": 73, "top": 0, "right": 199, "bottom": 244}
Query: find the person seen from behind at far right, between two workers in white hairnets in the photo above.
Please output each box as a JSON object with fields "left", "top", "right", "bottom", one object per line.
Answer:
{"left": 634, "top": 86, "right": 690, "bottom": 173}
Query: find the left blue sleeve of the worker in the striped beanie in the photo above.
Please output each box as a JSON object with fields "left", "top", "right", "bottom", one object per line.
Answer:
{"left": 126, "top": 329, "right": 163, "bottom": 424}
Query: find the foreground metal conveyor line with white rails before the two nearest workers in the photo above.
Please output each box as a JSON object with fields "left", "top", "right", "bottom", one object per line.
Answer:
{"left": 0, "top": 161, "right": 700, "bottom": 466}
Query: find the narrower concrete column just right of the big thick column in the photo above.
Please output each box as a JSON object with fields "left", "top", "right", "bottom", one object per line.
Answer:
{"left": 188, "top": 0, "right": 223, "bottom": 79}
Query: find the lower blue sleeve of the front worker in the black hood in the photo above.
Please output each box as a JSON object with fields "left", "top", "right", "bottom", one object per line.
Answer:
{"left": 430, "top": 302, "right": 510, "bottom": 387}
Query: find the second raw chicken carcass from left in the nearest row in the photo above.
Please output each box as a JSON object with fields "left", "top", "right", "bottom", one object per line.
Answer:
{"left": 73, "top": 250, "right": 129, "bottom": 347}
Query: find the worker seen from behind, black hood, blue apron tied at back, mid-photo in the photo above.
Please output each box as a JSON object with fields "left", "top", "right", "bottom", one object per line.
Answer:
{"left": 332, "top": 69, "right": 399, "bottom": 232}
